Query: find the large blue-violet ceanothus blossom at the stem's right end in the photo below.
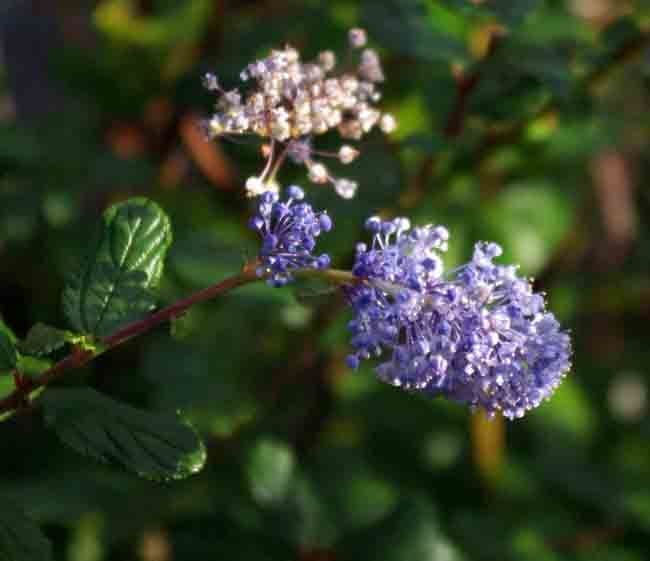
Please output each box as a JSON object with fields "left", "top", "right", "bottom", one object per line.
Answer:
{"left": 346, "top": 217, "right": 571, "bottom": 419}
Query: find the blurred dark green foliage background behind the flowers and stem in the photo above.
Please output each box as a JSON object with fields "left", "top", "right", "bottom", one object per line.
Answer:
{"left": 0, "top": 0, "right": 650, "bottom": 561}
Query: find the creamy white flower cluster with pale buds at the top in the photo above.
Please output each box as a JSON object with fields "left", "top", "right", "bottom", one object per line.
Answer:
{"left": 205, "top": 29, "right": 397, "bottom": 198}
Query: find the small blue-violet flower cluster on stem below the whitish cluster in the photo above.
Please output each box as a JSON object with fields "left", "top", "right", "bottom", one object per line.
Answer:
{"left": 250, "top": 185, "right": 332, "bottom": 286}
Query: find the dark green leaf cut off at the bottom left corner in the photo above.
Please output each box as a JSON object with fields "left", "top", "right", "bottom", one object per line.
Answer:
{"left": 0, "top": 498, "right": 52, "bottom": 561}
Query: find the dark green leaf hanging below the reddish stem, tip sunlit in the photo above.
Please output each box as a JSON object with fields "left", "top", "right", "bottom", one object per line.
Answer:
{"left": 42, "top": 388, "right": 206, "bottom": 480}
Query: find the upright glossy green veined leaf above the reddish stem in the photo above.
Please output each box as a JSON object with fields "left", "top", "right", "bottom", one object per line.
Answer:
{"left": 63, "top": 198, "right": 172, "bottom": 336}
